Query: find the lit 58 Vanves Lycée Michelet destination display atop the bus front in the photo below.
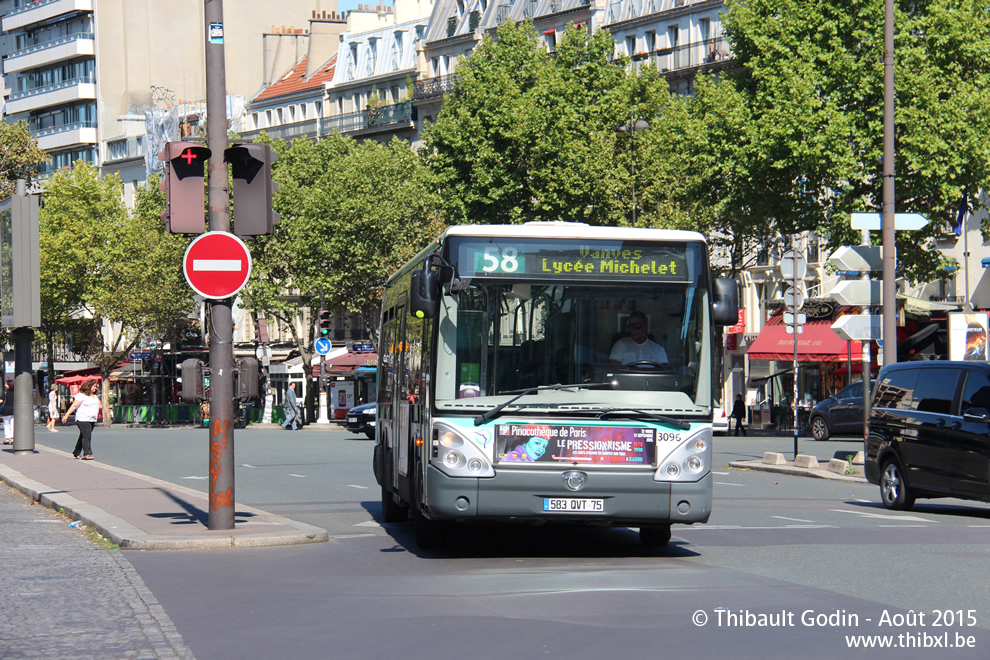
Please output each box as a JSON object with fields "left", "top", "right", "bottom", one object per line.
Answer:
{"left": 458, "top": 239, "right": 690, "bottom": 282}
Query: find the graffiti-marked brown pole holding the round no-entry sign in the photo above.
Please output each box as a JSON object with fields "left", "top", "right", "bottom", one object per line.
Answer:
{"left": 203, "top": 0, "right": 234, "bottom": 530}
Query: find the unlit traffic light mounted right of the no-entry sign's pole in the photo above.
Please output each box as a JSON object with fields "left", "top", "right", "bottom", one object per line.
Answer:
{"left": 223, "top": 143, "right": 279, "bottom": 236}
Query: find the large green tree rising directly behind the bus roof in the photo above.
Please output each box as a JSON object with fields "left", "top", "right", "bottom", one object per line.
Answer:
{"left": 423, "top": 22, "right": 629, "bottom": 225}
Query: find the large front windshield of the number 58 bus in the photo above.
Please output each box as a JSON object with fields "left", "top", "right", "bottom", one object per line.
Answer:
{"left": 435, "top": 243, "right": 712, "bottom": 415}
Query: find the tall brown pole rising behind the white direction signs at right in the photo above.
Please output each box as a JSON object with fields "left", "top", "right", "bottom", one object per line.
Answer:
{"left": 881, "top": 0, "right": 897, "bottom": 365}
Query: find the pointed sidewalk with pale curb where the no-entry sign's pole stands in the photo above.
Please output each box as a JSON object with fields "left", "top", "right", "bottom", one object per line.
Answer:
{"left": 0, "top": 446, "right": 329, "bottom": 550}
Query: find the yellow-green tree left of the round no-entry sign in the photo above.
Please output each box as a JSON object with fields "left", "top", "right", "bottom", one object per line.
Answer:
{"left": 40, "top": 161, "right": 195, "bottom": 418}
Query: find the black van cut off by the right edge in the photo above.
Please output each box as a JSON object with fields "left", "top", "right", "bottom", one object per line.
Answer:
{"left": 864, "top": 361, "right": 990, "bottom": 510}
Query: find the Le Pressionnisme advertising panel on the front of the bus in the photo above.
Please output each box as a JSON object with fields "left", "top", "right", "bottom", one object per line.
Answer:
{"left": 495, "top": 424, "right": 656, "bottom": 466}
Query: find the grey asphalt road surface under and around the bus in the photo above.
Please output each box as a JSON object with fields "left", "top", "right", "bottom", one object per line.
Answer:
{"left": 31, "top": 429, "right": 990, "bottom": 660}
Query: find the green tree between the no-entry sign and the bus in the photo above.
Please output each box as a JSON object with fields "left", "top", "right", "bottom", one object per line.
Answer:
{"left": 235, "top": 134, "right": 442, "bottom": 370}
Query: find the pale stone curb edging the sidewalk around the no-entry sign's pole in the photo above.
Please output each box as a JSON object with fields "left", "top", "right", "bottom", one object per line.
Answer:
{"left": 0, "top": 448, "right": 330, "bottom": 550}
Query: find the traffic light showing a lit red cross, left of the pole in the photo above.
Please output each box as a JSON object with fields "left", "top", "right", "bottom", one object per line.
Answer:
{"left": 158, "top": 142, "right": 210, "bottom": 234}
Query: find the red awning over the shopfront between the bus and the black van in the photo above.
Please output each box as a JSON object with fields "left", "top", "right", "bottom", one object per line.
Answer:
{"left": 746, "top": 314, "right": 862, "bottom": 362}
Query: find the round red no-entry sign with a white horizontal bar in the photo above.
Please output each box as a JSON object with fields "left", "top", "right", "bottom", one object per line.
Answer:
{"left": 182, "top": 231, "right": 251, "bottom": 299}
